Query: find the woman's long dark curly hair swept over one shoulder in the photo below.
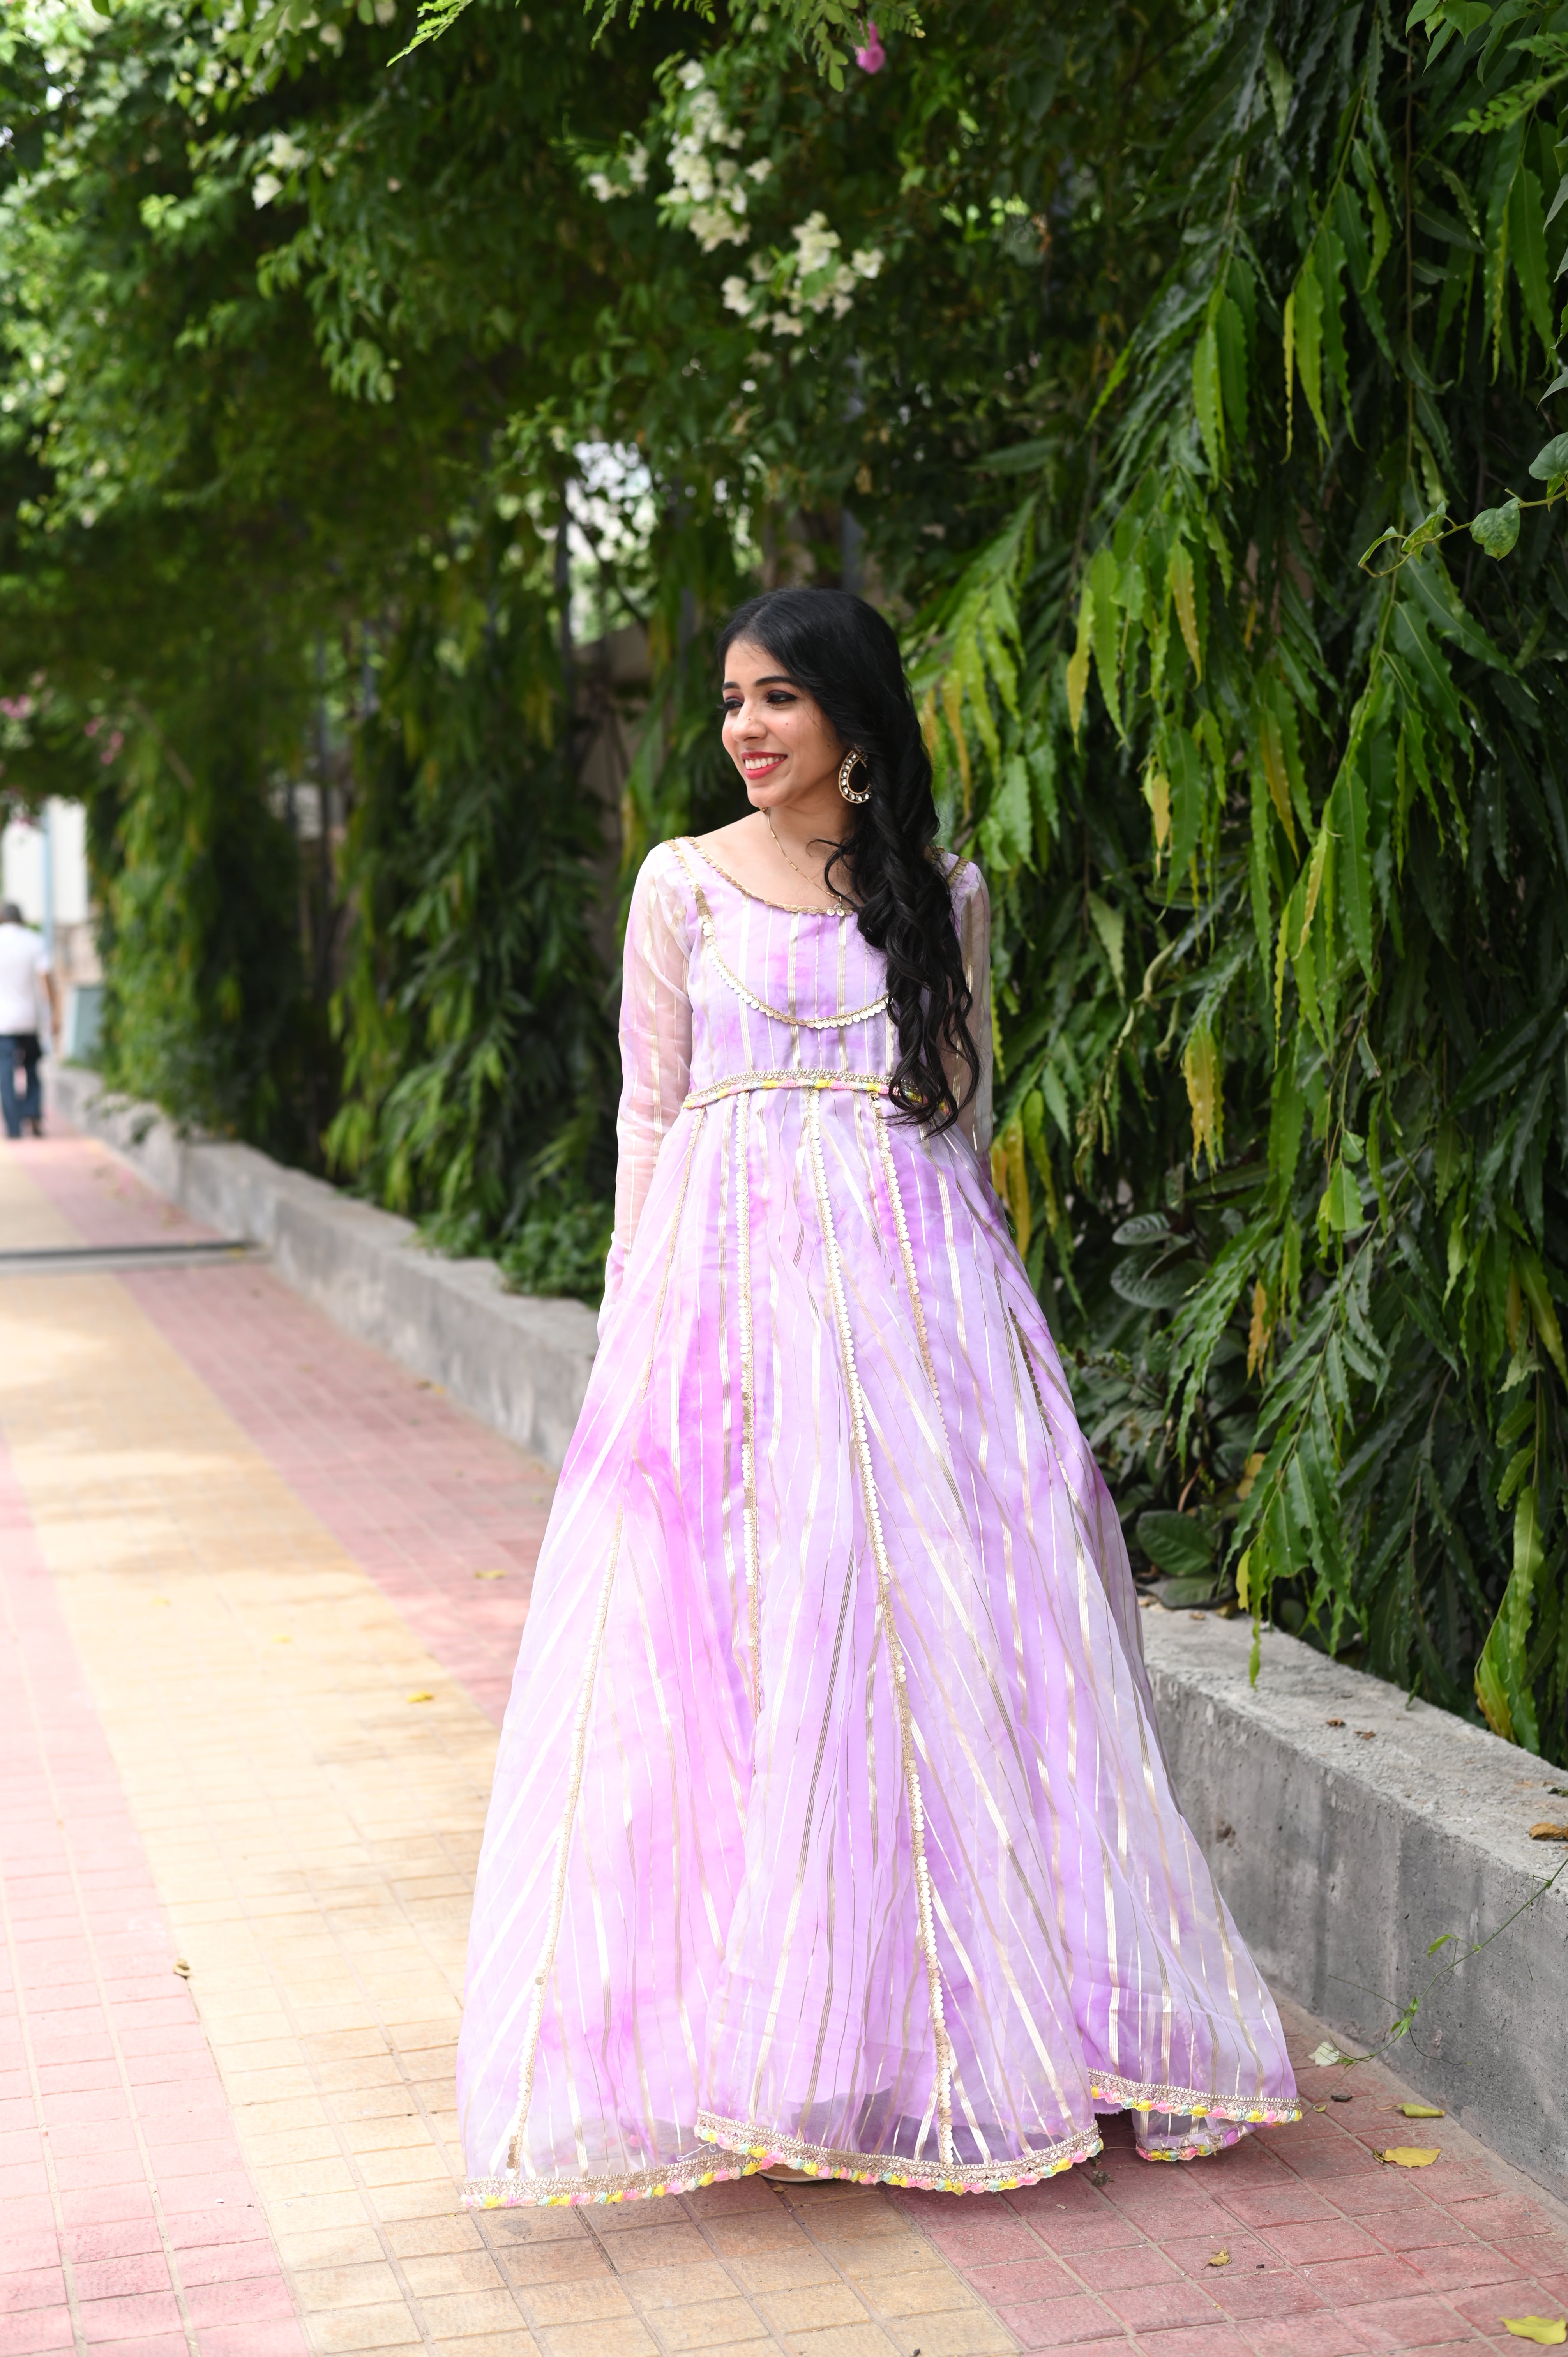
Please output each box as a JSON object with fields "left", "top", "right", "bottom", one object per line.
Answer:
{"left": 719, "top": 589, "right": 981, "bottom": 1131}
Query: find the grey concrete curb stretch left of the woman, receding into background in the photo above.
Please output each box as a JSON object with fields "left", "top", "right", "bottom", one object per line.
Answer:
{"left": 52, "top": 1065, "right": 599, "bottom": 1466}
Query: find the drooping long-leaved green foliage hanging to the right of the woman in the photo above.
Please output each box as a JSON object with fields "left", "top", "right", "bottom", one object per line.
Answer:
{"left": 927, "top": 0, "right": 1568, "bottom": 1761}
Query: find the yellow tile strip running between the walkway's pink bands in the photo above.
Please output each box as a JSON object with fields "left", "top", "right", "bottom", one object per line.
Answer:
{"left": 0, "top": 1157, "right": 1019, "bottom": 2357}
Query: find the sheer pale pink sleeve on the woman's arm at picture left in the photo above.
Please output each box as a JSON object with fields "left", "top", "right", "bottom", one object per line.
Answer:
{"left": 599, "top": 848, "right": 691, "bottom": 1341}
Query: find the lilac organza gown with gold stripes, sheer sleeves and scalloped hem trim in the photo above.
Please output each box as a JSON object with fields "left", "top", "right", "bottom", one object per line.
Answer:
{"left": 457, "top": 841, "right": 1297, "bottom": 2204}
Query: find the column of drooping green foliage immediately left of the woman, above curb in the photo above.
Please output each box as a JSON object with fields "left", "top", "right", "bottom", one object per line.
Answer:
{"left": 325, "top": 514, "right": 615, "bottom": 1244}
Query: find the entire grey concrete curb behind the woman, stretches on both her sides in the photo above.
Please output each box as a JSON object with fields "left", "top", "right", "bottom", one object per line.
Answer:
{"left": 42, "top": 1068, "right": 1568, "bottom": 2197}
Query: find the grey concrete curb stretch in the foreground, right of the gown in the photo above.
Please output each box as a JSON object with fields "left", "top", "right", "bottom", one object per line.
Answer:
{"left": 1144, "top": 1610, "right": 1568, "bottom": 2197}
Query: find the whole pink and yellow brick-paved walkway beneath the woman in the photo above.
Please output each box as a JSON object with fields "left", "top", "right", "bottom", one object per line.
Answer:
{"left": 0, "top": 1138, "right": 1568, "bottom": 2357}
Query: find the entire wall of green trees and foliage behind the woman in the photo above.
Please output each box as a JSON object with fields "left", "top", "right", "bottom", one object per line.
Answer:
{"left": 0, "top": 0, "right": 1568, "bottom": 1761}
